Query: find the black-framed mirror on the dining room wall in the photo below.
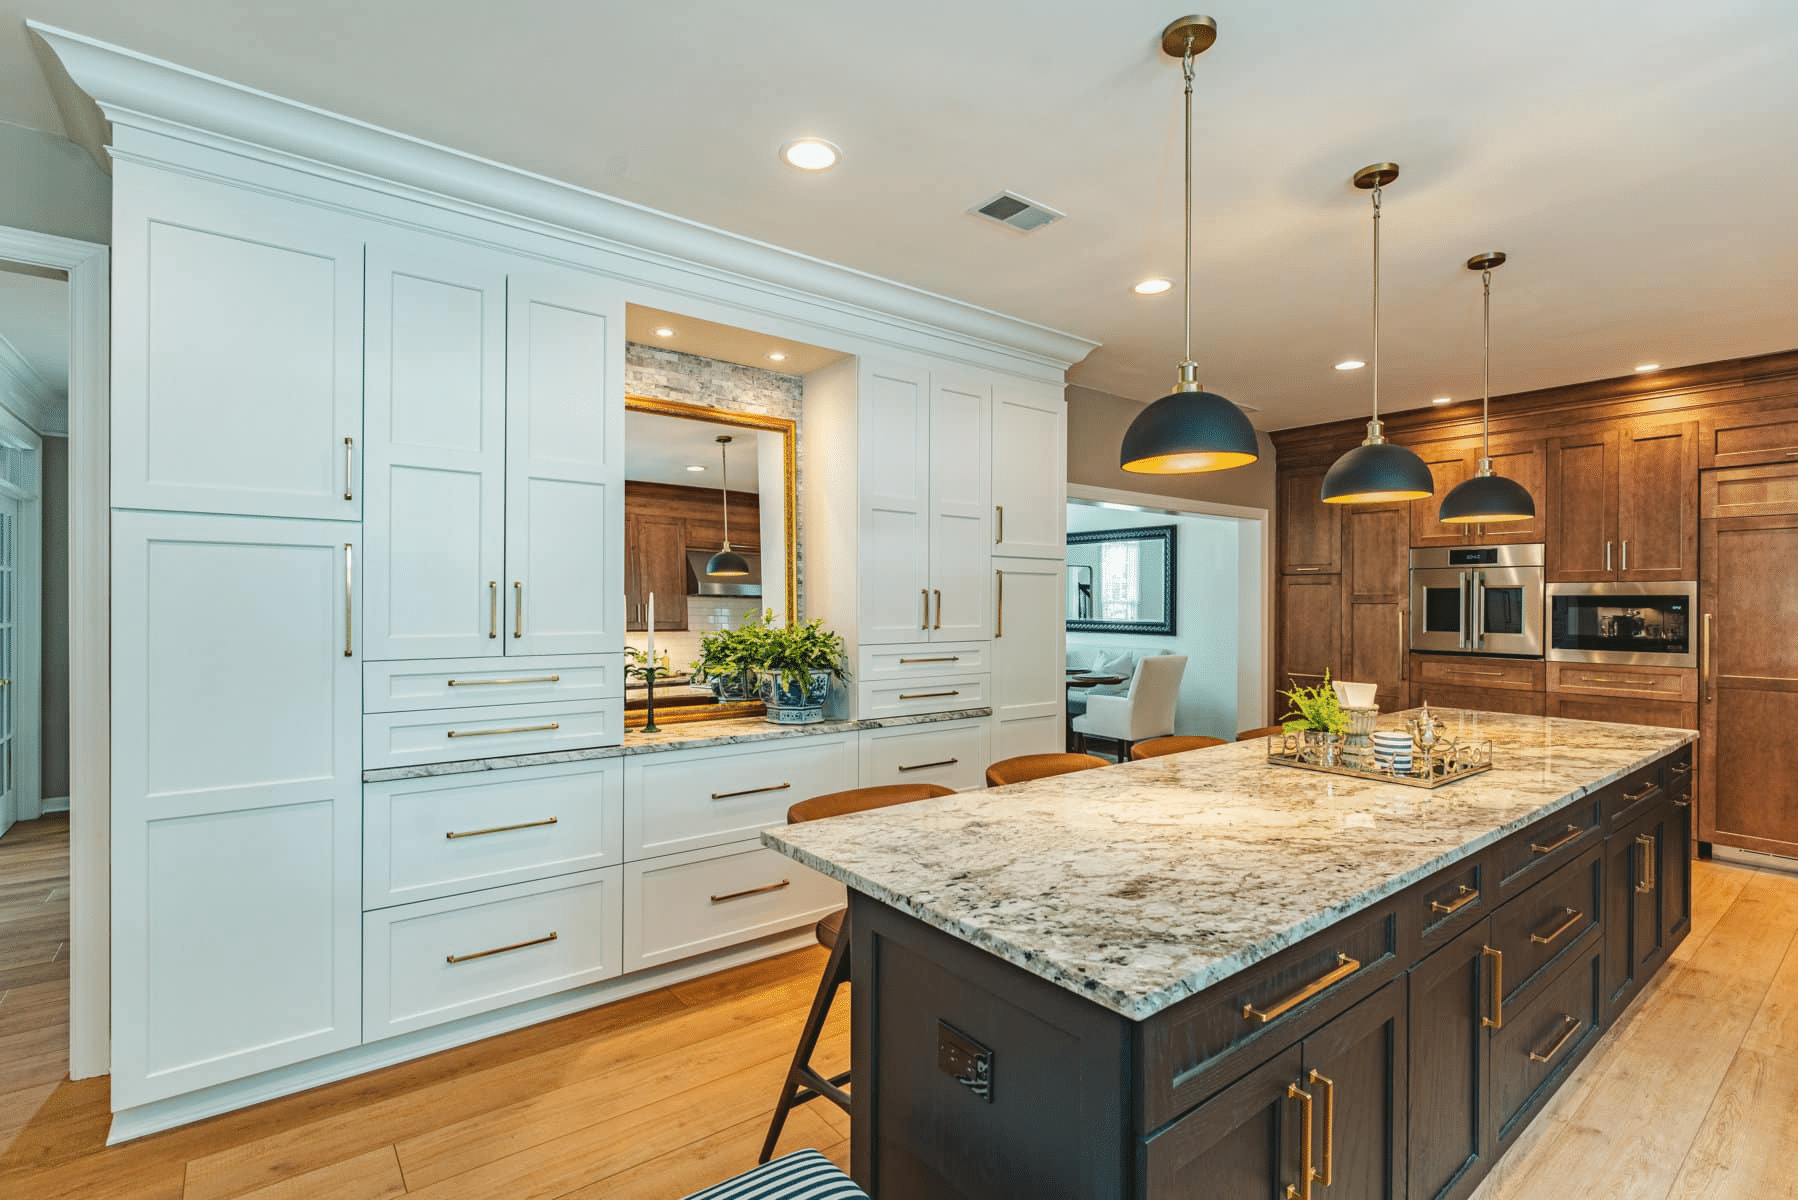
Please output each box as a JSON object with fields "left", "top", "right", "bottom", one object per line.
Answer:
{"left": 1068, "top": 525, "right": 1174, "bottom": 633}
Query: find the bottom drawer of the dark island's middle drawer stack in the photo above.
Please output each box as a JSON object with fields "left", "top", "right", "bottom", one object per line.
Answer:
{"left": 1492, "top": 945, "right": 1604, "bottom": 1157}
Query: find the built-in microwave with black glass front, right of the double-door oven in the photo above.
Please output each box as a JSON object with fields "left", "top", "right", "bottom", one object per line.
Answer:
{"left": 1548, "top": 579, "right": 1697, "bottom": 667}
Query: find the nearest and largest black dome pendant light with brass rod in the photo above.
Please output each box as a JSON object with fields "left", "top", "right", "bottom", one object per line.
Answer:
{"left": 1118, "top": 16, "right": 1260, "bottom": 475}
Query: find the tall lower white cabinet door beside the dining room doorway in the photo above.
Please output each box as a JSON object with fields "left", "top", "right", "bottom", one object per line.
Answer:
{"left": 992, "top": 558, "right": 1068, "bottom": 759}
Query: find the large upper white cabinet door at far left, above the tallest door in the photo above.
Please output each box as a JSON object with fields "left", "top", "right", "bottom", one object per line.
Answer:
{"left": 111, "top": 162, "right": 363, "bottom": 520}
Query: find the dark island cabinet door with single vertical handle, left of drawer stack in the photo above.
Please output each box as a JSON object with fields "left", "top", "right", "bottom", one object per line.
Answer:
{"left": 1406, "top": 921, "right": 1494, "bottom": 1200}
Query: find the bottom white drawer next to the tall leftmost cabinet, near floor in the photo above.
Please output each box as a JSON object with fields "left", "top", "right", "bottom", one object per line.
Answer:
{"left": 361, "top": 867, "right": 624, "bottom": 1042}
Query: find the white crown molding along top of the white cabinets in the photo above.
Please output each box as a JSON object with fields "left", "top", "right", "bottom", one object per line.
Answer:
{"left": 27, "top": 22, "right": 1099, "bottom": 371}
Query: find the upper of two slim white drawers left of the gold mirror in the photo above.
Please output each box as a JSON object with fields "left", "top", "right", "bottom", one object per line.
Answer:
{"left": 361, "top": 655, "right": 624, "bottom": 712}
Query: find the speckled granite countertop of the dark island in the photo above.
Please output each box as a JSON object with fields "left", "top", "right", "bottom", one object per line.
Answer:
{"left": 762, "top": 711, "right": 1696, "bottom": 1020}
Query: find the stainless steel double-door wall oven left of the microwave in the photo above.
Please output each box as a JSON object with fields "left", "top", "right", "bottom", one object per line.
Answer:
{"left": 1411, "top": 543, "right": 1544, "bottom": 658}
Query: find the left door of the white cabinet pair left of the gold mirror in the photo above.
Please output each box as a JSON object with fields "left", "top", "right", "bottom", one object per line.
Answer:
{"left": 365, "top": 239, "right": 505, "bottom": 660}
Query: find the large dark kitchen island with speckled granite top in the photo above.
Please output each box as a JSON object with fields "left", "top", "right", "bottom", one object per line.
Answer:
{"left": 764, "top": 712, "right": 1692, "bottom": 1200}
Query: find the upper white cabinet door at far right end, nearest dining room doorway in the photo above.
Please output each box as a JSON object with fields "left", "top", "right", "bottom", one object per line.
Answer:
{"left": 992, "top": 376, "right": 1068, "bottom": 561}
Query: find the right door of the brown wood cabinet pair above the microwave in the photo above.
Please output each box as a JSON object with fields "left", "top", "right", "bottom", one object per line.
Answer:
{"left": 1616, "top": 421, "right": 1697, "bottom": 583}
